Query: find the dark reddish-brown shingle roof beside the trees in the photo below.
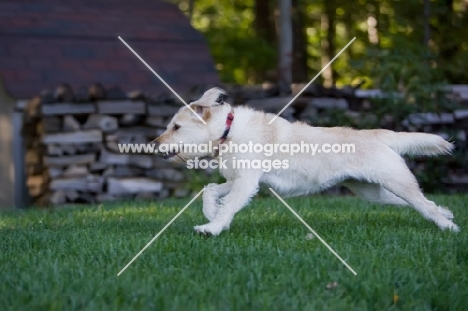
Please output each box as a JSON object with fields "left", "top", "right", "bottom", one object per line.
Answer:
{"left": 0, "top": 0, "right": 219, "bottom": 98}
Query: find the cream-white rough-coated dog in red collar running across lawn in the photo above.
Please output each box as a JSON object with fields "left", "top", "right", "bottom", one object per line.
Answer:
{"left": 156, "top": 88, "right": 459, "bottom": 235}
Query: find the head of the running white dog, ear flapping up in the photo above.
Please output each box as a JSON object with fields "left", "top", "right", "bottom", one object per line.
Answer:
{"left": 154, "top": 87, "right": 231, "bottom": 163}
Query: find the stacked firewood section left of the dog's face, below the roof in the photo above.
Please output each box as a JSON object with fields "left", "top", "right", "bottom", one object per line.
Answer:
{"left": 23, "top": 85, "right": 186, "bottom": 205}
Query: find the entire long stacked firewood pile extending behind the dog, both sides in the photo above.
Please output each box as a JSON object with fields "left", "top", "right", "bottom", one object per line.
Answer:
{"left": 23, "top": 84, "right": 468, "bottom": 204}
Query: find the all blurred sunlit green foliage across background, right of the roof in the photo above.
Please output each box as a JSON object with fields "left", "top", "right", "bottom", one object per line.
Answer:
{"left": 171, "top": 0, "right": 468, "bottom": 87}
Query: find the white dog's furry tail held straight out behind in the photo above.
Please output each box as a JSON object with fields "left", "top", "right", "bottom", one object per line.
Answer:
{"left": 378, "top": 131, "right": 454, "bottom": 156}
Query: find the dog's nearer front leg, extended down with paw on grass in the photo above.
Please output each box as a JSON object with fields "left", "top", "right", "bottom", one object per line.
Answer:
{"left": 194, "top": 176, "right": 259, "bottom": 235}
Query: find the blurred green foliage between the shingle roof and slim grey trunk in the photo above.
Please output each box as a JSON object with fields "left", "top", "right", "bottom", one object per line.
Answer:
{"left": 170, "top": 0, "right": 276, "bottom": 83}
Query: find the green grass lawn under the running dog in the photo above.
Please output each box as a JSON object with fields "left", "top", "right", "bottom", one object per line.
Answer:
{"left": 0, "top": 195, "right": 468, "bottom": 310}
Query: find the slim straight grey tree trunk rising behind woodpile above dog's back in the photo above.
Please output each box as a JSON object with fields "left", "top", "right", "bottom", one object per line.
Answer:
{"left": 278, "top": 0, "right": 293, "bottom": 94}
